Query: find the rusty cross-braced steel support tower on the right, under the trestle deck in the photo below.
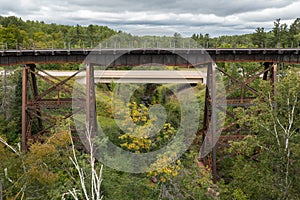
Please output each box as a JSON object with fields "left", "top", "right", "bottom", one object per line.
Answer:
{"left": 202, "top": 62, "right": 277, "bottom": 181}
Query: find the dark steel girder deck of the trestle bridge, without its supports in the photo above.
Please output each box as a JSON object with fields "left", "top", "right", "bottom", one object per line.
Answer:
{"left": 0, "top": 48, "right": 300, "bottom": 67}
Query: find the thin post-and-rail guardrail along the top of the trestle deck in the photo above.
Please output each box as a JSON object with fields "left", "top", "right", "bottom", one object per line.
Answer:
{"left": 0, "top": 38, "right": 300, "bottom": 51}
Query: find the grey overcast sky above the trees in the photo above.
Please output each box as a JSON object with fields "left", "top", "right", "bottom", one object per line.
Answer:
{"left": 0, "top": 0, "right": 300, "bottom": 36}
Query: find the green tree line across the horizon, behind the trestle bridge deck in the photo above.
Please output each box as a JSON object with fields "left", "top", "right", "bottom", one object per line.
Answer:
{"left": 0, "top": 16, "right": 300, "bottom": 49}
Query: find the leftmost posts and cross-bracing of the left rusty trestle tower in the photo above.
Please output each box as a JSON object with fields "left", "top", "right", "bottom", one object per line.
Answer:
{"left": 22, "top": 64, "right": 84, "bottom": 151}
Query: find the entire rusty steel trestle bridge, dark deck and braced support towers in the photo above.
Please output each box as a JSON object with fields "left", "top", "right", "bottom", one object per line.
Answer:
{"left": 0, "top": 48, "right": 300, "bottom": 180}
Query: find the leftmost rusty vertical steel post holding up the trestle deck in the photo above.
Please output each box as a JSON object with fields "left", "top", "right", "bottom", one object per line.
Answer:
{"left": 22, "top": 66, "right": 28, "bottom": 152}
